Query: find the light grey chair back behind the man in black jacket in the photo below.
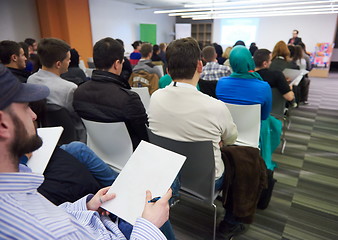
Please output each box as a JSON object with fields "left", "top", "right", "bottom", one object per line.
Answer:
{"left": 82, "top": 118, "right": 133, "bottom": 172}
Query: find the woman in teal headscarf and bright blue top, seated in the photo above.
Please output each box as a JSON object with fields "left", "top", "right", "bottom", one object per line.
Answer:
{"left": 216, "top": 46, "right": 282, "bottom": 170}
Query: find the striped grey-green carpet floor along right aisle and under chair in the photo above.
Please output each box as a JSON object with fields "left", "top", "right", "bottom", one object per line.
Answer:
{"left": 170, "top": 73, "right": 338, "bottom": 240}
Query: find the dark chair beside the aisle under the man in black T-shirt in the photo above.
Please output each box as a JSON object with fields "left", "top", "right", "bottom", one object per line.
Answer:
{"left": 271, "top": 88, "right": 289, "bottom": 154}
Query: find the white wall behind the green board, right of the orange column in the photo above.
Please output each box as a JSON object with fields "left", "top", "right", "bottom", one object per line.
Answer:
{"left": 89, "top": 0, "right": 175, "bottom": 52}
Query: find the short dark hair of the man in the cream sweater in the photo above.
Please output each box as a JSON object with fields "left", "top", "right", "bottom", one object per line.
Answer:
{"left": 166, "top": 37, "right": 201, "bottom": 80}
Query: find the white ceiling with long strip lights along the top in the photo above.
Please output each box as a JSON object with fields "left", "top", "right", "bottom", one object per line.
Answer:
{"left": 115, "top": 0, "right": 338, "bottom": 20}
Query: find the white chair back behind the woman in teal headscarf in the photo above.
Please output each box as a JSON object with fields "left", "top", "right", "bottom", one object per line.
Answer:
{"left": 225, "top": 103, "right": 261, "bottom": 148}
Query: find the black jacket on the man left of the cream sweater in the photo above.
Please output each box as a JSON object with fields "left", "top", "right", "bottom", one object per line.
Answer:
{"left": 73, "top": 70, "right": 148, "bottom": 149}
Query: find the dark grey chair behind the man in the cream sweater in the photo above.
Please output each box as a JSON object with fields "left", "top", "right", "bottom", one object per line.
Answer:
{"left": 147, "top": 128, "right": 219, "bottom": 239}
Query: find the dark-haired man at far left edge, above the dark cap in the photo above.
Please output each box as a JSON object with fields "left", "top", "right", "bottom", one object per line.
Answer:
{"left": 0, "top": 40, "right": 30, "bottom": 83}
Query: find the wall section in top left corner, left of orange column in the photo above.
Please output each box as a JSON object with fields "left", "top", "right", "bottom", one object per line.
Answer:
{"left": 0, "top": 0, "right": 40, "bottom": 42}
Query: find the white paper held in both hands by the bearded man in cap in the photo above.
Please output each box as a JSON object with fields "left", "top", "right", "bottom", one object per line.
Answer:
{"left": 102, "top": 141, "right": 186, "bottom": 225}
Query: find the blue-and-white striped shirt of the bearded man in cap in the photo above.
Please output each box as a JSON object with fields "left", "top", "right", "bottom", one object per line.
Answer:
{"left": 0, "top": 173, "right": 166, "bottom": 240}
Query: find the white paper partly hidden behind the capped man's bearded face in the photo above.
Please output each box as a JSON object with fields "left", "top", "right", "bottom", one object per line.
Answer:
{"left": 27, "top": 127, "right": 63, "bottom": 174}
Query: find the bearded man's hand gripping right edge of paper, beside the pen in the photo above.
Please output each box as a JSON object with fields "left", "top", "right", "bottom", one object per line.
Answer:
{"left": 142, "top": 189, "right": 172, "bottom": 228}
